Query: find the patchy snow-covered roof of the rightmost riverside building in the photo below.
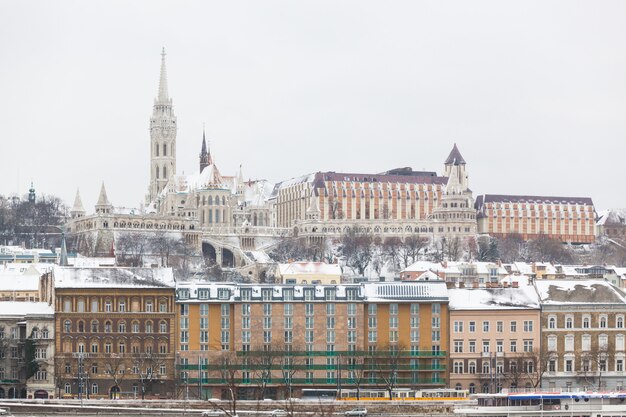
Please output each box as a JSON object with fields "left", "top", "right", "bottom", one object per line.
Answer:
{"left": 535, "top": 279, "right": 626, "bottom": 304}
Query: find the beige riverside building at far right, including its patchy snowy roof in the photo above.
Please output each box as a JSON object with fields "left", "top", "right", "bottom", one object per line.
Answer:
{"left": 535, "top": 280, "right": 626, "bottom": 389}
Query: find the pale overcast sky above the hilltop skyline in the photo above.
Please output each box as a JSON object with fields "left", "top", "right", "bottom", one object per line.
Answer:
{"left": 0, "top": 0, "right": 626, "bottom": 212}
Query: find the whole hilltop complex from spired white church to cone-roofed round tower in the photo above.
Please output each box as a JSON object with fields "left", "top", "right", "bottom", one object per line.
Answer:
{"left": 67, "top": 51, "right": 476, "bottom": 267}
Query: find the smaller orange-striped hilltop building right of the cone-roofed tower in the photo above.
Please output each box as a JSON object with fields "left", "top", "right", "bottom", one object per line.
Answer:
{"left": 475, "top": 194, "right": 596, "bottom": 243}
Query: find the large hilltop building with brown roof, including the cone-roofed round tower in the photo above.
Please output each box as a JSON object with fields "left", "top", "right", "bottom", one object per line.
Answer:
{"left": 274, "top": 144, "right": 476, "bottom": 238}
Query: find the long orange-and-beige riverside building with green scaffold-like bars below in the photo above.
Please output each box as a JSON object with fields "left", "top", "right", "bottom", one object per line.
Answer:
{"left": 176, "top": 282, "right": 449, "bottom": 399}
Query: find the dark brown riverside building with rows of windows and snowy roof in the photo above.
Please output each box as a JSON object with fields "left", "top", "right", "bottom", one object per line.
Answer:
{"left": 54, "top": 267, "right": 176, "bottom": 399}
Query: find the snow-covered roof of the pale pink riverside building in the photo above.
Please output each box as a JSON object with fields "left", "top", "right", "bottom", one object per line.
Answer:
{"left": 448, "top": 284, "right": 539, "bottom": 310}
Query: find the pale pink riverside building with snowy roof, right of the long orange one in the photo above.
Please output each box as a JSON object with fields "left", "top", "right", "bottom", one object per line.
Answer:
{"left": 448, "top": 285, "right": 541, "bottom": 392}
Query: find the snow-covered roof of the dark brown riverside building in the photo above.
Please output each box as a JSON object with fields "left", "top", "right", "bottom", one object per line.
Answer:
{"left": 54, "top": 266, "right": 175, "bottom": 288}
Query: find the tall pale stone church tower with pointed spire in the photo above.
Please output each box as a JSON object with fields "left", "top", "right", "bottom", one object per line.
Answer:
{"left": 148, "top": 48, "right": 176, "bottom": 203}
